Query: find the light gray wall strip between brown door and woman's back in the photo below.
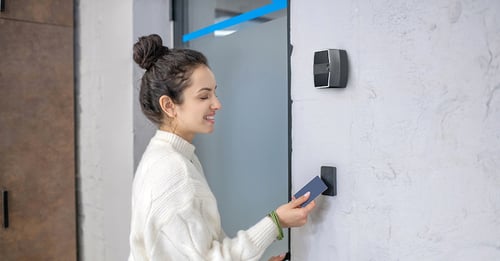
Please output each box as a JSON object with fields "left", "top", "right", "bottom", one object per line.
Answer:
{"left": 75, "top": 0, "right": 170, "bottom": 261}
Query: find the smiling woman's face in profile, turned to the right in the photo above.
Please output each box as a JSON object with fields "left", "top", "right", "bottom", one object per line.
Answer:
{"left": 173, "top": 65, "right": 221, "bottom": 142}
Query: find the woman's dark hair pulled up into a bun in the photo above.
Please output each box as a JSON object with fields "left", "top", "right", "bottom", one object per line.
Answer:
{"left": 134, "top": 34, "right": 208, "bottom": 125}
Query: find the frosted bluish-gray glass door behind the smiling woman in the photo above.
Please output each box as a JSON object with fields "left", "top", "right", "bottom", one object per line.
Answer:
{"left": 176, "top": 0, "right": 289, "bottom": 260}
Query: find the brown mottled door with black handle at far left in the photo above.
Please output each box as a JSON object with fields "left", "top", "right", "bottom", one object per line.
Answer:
{"left": 0, "top": 0, "right": 77, "bottom": 261}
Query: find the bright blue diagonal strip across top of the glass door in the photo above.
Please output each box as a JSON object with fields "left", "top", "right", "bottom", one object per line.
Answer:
{"left": 182, "top": 0, "right": 287, "bottom": 42}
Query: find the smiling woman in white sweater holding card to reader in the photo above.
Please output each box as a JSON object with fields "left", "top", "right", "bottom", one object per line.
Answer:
{"left": 129, "top": 35, "right": 315, "bottom": 261}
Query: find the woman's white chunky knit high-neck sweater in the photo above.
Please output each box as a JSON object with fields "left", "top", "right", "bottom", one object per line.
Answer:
{"left": 129, "top": 130, "right": 278, "bottom": 261}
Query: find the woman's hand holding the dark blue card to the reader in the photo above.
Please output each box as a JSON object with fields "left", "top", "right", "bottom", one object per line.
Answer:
{"left": 276, "top": 192, "right": 316, "bottom": 228}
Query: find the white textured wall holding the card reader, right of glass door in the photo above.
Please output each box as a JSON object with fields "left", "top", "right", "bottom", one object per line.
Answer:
{"left": 291, "top": 0, "right": 500, "bottom": 261}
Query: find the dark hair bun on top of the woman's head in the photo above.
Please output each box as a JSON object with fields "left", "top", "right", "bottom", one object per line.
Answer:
{"left": 134, "top": 34, "right": 169, "bottom": 70}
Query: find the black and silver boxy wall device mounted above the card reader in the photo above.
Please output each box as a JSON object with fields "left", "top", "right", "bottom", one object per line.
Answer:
{"left": 314, "top": 49, "right": 347, "bottom": 88}
